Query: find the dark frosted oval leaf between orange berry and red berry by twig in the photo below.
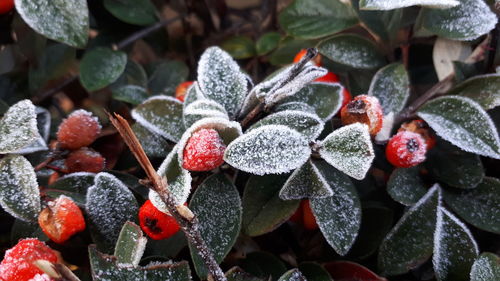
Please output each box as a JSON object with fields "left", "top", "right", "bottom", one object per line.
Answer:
{"left": 85, "top": 173, "right": 139, "bottom": 251}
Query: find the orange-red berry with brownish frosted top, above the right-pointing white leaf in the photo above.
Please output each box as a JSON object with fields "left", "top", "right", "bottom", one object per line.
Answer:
{"left": 340, "top": 95, "right": 384, "bottom": 136}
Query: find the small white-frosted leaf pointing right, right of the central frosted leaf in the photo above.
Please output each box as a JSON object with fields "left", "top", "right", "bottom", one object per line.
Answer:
{"left": 319, "top": 123, "right": 375, "bottom": 180}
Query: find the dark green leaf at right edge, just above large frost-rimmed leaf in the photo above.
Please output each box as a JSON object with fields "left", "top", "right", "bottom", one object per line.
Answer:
{"left": 448, "top": 74, "right": 500, "bottom": 110}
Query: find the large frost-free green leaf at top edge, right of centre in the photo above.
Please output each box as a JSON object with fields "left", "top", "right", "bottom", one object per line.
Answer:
{"left": 279, "top": 0, "right": 358, "bottom": 39}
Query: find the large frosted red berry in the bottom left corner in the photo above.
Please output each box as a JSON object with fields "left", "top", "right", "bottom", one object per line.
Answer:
{"left": 0, "top": 238, "right": 58, "bottom": 281}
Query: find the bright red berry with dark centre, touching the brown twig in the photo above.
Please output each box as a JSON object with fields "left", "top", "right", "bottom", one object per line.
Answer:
{"left": 139, "top": 200, "right": 180, "bottom": 240}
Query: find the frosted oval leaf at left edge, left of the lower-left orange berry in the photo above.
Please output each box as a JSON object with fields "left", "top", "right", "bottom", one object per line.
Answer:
{"left": 0, "top": 155, "right": 41, "bottom": 222}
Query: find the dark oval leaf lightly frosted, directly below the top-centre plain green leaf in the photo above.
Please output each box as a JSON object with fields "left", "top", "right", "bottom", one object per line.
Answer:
{"left": 318, "top": 34, "right": 385, "bottom": 69}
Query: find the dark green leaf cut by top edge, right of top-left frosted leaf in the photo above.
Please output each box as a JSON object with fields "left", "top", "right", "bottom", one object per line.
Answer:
{"left": 104, "top": 0, "right": 157, "bottom": 25}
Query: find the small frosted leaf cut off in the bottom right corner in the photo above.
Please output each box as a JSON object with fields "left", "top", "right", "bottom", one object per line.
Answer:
{"left": 470, "top": 253, "right": 500, "bottom": 281}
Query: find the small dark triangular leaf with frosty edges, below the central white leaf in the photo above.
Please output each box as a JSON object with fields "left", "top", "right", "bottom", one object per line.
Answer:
{"left": 279, "top": 160, "right": 333, "bottom": 200}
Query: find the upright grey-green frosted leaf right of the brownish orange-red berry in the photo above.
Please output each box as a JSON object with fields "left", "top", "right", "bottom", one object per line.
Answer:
{"left": 368, "top": 63, "right": 410, "bottom": 115}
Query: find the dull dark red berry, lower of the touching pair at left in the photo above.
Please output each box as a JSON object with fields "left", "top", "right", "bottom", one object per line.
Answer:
{"left": 64, "top": 147, "right": 106, "bottom": 173}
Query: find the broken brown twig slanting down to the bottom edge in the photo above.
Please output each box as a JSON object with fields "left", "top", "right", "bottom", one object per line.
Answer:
{"left": 109, "top": 113, "right": 227, "bottom": 281}
